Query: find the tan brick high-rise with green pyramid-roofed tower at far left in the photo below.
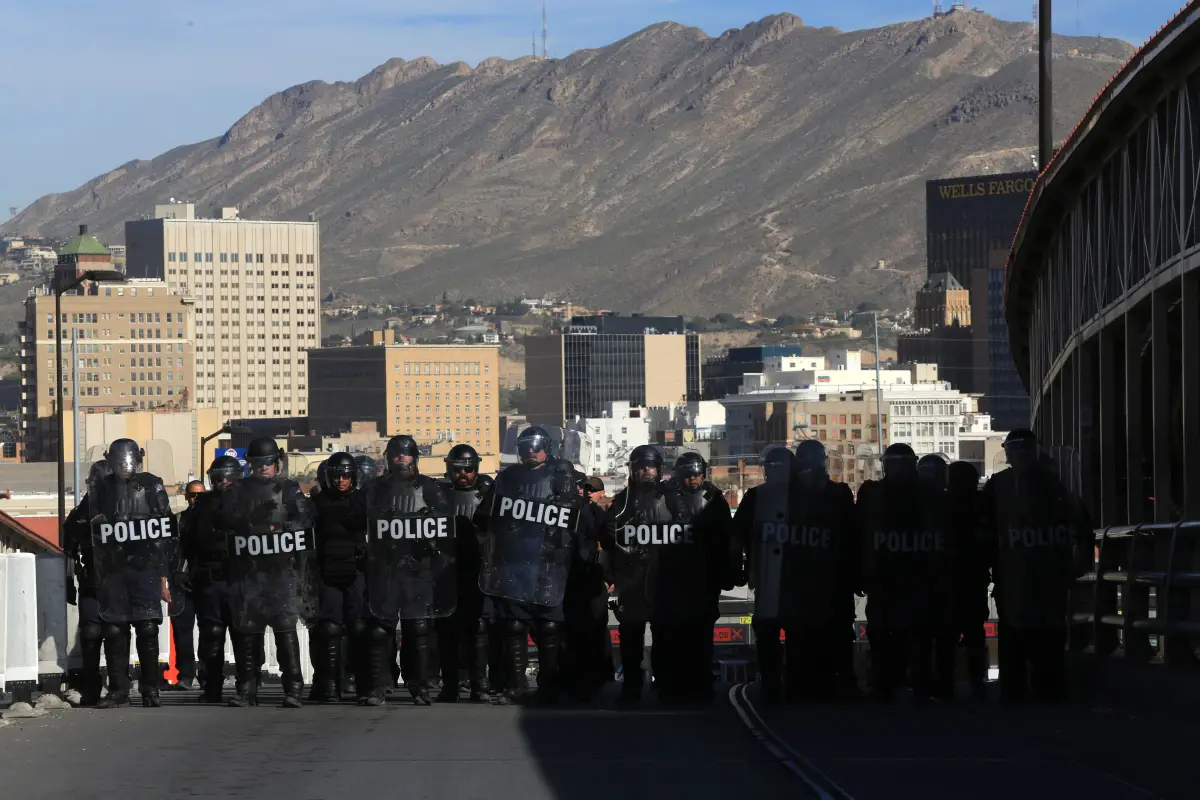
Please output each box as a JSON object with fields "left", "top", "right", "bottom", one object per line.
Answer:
{"left": 18, "top": 229, "right": 196, "bottom": 461}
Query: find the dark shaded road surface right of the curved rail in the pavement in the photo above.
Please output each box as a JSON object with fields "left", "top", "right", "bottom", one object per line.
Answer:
{"left": 732, "top": 686, "right": 1200, "bottom": 800}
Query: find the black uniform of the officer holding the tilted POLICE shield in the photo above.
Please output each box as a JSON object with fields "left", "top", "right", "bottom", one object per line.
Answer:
{"left": 475, "top": 455, "right": 595, "bottom": 703}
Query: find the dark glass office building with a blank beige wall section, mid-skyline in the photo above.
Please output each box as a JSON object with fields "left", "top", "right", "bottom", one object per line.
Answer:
{"left": 524, "top": 314, "right": 701, "bottom": 426}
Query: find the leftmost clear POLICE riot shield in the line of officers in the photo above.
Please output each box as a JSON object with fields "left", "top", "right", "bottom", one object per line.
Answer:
{"left": 85, "top": 476, "right": 184, "bottom": 622}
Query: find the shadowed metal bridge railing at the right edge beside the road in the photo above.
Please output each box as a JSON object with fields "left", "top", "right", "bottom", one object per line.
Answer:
{"left": 1070, "top": 522, "right": 1200, "bottom": 667}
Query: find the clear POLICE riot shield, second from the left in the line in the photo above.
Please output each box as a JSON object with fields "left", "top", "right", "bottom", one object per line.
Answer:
{"left": 221, "top": 479, "right": 318, "bottom": 632}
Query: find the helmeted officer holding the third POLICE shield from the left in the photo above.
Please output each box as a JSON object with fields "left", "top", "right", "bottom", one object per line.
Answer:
{"left": 358, "top": 434, "right": 457, "bottom": 705}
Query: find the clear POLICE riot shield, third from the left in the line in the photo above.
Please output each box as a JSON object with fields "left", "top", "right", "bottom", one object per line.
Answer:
{"left": 366, "top": 510, "right": 458, "bottom": 620}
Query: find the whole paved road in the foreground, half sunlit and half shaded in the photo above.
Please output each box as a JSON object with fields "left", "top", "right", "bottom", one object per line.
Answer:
{"left": 0, "top": 687, "right": 1200, "bottom": 800}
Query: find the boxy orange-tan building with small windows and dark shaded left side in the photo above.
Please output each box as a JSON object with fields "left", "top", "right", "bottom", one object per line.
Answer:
{"left": 308, "top": 344, "right": 500, "bottom": 473}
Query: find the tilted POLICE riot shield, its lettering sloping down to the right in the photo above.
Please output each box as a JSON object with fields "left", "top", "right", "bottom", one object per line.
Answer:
{"left": 479, "top": 482, "right": 580, "bottom": 607}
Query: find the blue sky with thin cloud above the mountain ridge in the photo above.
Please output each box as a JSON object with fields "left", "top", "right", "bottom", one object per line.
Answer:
{"left": 0, "top": 0, "right": 1184, "bottom": 212}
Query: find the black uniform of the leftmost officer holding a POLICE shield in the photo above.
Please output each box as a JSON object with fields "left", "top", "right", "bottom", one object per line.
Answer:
{"left": 64, "top": 473, "right": 175, "bottom": 708}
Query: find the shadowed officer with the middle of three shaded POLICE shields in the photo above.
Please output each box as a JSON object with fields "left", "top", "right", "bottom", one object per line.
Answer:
{"left": 858, "top": 444, "right": 950, "bottom": 702}
